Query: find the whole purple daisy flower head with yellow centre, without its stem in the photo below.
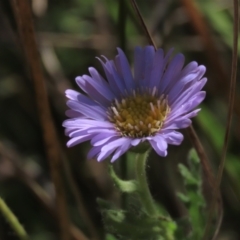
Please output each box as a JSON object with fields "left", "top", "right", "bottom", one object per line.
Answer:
{"left": 63, "top": 46, "right": 207, "bottom": 162}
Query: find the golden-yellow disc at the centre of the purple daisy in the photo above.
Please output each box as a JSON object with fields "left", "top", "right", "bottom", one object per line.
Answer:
{"left": 107, "top": 88, "right": 170, "bottom": 137}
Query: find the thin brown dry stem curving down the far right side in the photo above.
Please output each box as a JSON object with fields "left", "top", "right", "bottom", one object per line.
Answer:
{"left": 203, "top": 0, "right": 239, "bottom": 240}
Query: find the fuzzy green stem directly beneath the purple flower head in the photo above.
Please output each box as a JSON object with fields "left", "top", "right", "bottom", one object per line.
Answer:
{"left": 135, "top": 150, "right": 157, "bottom": 217}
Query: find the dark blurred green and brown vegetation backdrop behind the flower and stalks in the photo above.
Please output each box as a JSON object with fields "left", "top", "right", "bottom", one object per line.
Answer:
{"left": 0, "top": 0, "right": 240, "bottom": 240}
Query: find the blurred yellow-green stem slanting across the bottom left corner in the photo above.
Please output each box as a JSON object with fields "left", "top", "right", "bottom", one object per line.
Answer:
{"left": 0, "top": 198, "right": 28, "bottom": 240}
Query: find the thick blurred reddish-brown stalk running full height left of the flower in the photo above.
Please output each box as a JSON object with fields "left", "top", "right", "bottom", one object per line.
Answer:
{"left": 11, "top": 0, "right": 70, "bottom": 240}
